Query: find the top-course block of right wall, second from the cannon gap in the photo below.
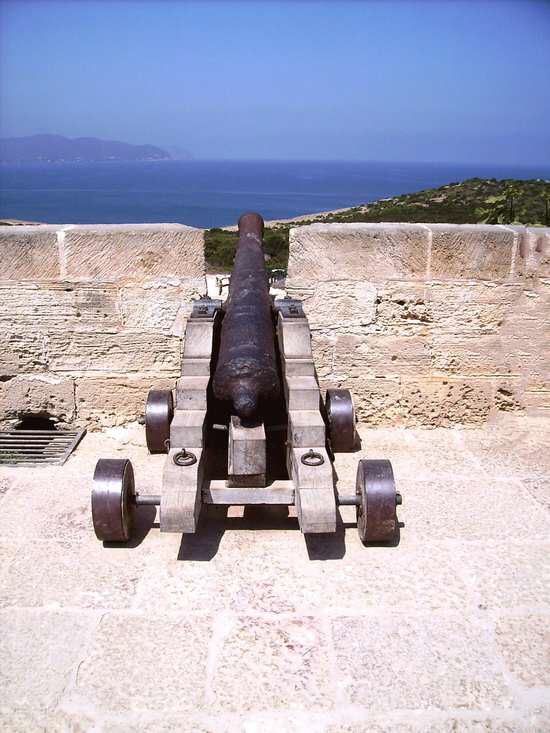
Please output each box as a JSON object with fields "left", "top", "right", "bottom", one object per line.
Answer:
{"left": 427, "top": 224, "right": 517, "bottom": 280}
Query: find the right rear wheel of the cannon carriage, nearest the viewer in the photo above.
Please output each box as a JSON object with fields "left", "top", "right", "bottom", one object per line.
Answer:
{"left": 355, "top": 459, "right": 398, "bottom": 544}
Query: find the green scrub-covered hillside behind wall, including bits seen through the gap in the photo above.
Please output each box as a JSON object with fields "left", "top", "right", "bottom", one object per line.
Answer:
{"left": 205, "top": 178, "right": 550, "bottom": 272}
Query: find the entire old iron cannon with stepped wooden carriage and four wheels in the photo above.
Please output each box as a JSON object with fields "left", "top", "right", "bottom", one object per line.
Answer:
{"left": 92, "top": 214, "right": 401, "bottom": 544}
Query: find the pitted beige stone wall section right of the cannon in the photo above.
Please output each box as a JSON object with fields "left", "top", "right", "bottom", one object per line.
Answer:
{"left": 287, "top": 224, "right": 550, "bottom": 426}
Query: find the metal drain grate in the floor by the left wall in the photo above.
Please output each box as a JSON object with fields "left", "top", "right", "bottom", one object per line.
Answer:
{"left": 0, "top": 428, "right": 86, "bottom": 466}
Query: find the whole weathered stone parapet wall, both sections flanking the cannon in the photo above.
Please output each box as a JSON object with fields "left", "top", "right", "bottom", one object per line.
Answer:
{"left": 0, "top": 224, "right": 550, "bottom": 427}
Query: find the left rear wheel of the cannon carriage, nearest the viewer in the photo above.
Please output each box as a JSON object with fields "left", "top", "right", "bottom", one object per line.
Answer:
{"left": 92, "top": 458, "right": 135, "bottom": 542}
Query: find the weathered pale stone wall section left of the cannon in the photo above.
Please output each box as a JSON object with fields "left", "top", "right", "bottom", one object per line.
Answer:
{"left": 0, "top": 224, "right": 205, "bottom": 427}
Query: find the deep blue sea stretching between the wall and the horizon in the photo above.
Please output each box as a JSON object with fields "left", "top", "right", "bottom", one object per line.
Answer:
{"left": 0, "top": 160, "right": 550, "bottom": 228}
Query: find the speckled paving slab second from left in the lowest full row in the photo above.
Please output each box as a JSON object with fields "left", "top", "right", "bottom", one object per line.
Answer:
{"left": 72, "top": 613, "right": 211, "bottom": 715}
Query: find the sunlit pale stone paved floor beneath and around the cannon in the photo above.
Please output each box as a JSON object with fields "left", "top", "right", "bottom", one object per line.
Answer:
{"left": 0, "top": 418, "right": 550, "bottom": 733}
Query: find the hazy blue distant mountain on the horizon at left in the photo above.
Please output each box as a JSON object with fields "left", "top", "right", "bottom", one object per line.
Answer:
{"left": 0, "top": 135, "right": 171, "bottom": 163}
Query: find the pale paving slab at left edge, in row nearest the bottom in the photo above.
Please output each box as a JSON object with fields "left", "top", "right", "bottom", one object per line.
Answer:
{"left": 0, "top": 608, "right": 98, "bottom": 708}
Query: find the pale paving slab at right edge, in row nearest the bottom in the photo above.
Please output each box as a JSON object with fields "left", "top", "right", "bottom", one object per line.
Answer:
{"left": 496, "top": 614, "right": 550, "bottom": 687}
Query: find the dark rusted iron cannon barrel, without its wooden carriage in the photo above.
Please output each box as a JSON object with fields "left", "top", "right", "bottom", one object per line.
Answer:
{"left": 212, "top": 214, "right": 280, "bottom": 424}
